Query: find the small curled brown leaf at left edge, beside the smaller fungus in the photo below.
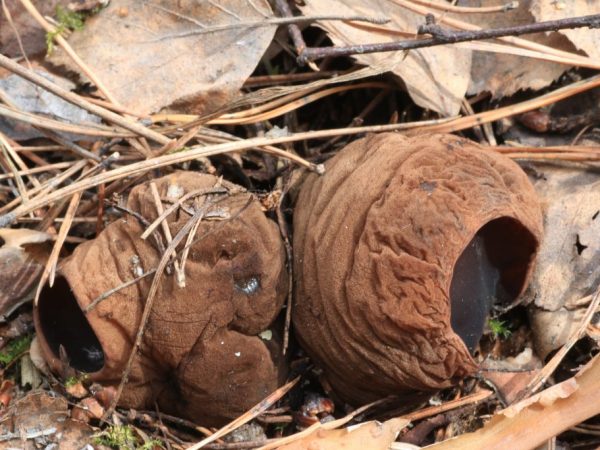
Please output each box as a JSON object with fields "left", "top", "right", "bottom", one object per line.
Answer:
{"left": 0, "top": 228, "right": 51, "bottom": 321}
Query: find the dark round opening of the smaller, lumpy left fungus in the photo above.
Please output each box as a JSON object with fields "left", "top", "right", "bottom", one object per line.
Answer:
{"left": 38, "top": 277, "right": 104, "bottom": 373}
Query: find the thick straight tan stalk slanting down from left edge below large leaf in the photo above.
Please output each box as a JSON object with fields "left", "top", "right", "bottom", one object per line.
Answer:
{"left": 0, "top": 54, "right": 171, "bottom": 145}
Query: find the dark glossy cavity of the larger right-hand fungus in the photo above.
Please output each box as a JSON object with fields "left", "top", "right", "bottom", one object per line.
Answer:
{"left": 450, "top": 217, "right": 537, "bottom": 352}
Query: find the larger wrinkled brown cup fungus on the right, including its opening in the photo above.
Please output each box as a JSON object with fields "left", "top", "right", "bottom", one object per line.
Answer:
{"left": 293, "top": 134, "right": 542, "bottom": 404}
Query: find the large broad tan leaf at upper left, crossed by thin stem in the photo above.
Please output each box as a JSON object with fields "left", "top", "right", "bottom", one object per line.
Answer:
{"left": 50, "top": 0, "right": 275, "bottom": 114}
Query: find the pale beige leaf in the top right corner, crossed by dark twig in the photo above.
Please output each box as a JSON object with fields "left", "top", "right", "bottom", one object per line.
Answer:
{"left": 530, "top": 0, "right": 600, "bottom": 58}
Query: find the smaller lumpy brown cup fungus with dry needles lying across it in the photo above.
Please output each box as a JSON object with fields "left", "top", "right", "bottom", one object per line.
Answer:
{"left": 35, "top": 172, "right": 287, "bottom": 425}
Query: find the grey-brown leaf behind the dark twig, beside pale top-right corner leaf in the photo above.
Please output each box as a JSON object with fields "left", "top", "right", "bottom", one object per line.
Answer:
{"left": 454, "top": 0, "right": 576, "bottom": 98}
